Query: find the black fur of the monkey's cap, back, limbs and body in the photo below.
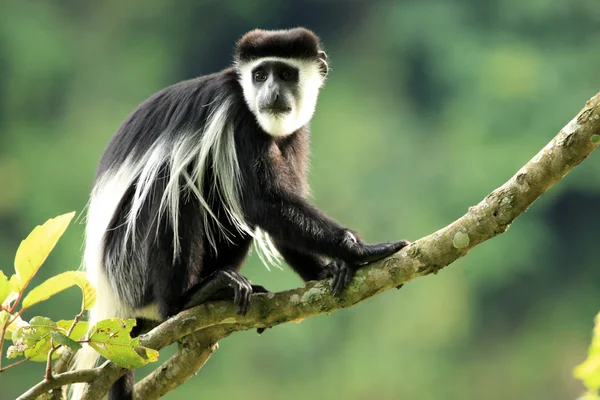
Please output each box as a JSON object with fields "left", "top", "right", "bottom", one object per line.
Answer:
{"left": 96, "top": 29, "right": 406, "bottom": 400}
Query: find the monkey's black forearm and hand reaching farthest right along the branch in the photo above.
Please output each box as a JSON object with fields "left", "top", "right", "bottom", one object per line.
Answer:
{"left": 247, "top": 194, "right": 408, "bottom": 265}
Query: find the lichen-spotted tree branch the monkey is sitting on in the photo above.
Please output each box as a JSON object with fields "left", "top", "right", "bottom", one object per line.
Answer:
{"left": 23, "top": 93, "right": 600, "bottom": 399}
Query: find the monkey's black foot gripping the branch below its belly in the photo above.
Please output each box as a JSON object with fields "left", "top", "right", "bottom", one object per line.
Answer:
{"left": 184, "top": 270, "right": 255, "bottom": 315}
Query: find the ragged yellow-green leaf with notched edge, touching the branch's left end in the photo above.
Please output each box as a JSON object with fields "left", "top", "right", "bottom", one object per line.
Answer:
{"left": 88, "top": 318, "right": 158, "bottom": 369}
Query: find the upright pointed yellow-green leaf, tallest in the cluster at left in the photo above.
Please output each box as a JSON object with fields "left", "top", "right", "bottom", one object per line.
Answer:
{"left": 11, "top": 212, "right": 75, "bottom": 292}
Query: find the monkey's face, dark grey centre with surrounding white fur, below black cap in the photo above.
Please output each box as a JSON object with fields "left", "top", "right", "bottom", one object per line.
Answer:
{"left": 240, "top": 57, "right": 324, "bottom": 136}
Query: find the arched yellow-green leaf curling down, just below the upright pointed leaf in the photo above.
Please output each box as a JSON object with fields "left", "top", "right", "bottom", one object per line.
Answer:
{"left": 23, "top": 271, "right": 96, "bottom": 310}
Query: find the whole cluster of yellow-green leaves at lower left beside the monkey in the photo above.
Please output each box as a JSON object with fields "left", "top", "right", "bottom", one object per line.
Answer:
{"left": 0, "top": 212, "right": 158, "bottom": 379}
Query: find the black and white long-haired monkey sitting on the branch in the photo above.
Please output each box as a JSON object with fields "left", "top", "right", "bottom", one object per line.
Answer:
{"left": 74, "top": 28, "right": 407, "bottom": 400}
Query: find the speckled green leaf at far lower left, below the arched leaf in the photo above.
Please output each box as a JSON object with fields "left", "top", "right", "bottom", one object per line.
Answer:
{"left": 7, "top": 317, "right": 56, "bottom": 361}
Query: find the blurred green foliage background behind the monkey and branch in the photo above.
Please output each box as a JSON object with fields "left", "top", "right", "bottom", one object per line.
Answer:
{"left": 0, "top": 0, "right": 600, "bottom": 400}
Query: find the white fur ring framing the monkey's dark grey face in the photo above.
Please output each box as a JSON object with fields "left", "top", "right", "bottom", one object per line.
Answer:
{"left": 239, "top": 57, "right": 324, "bottom": 136}
